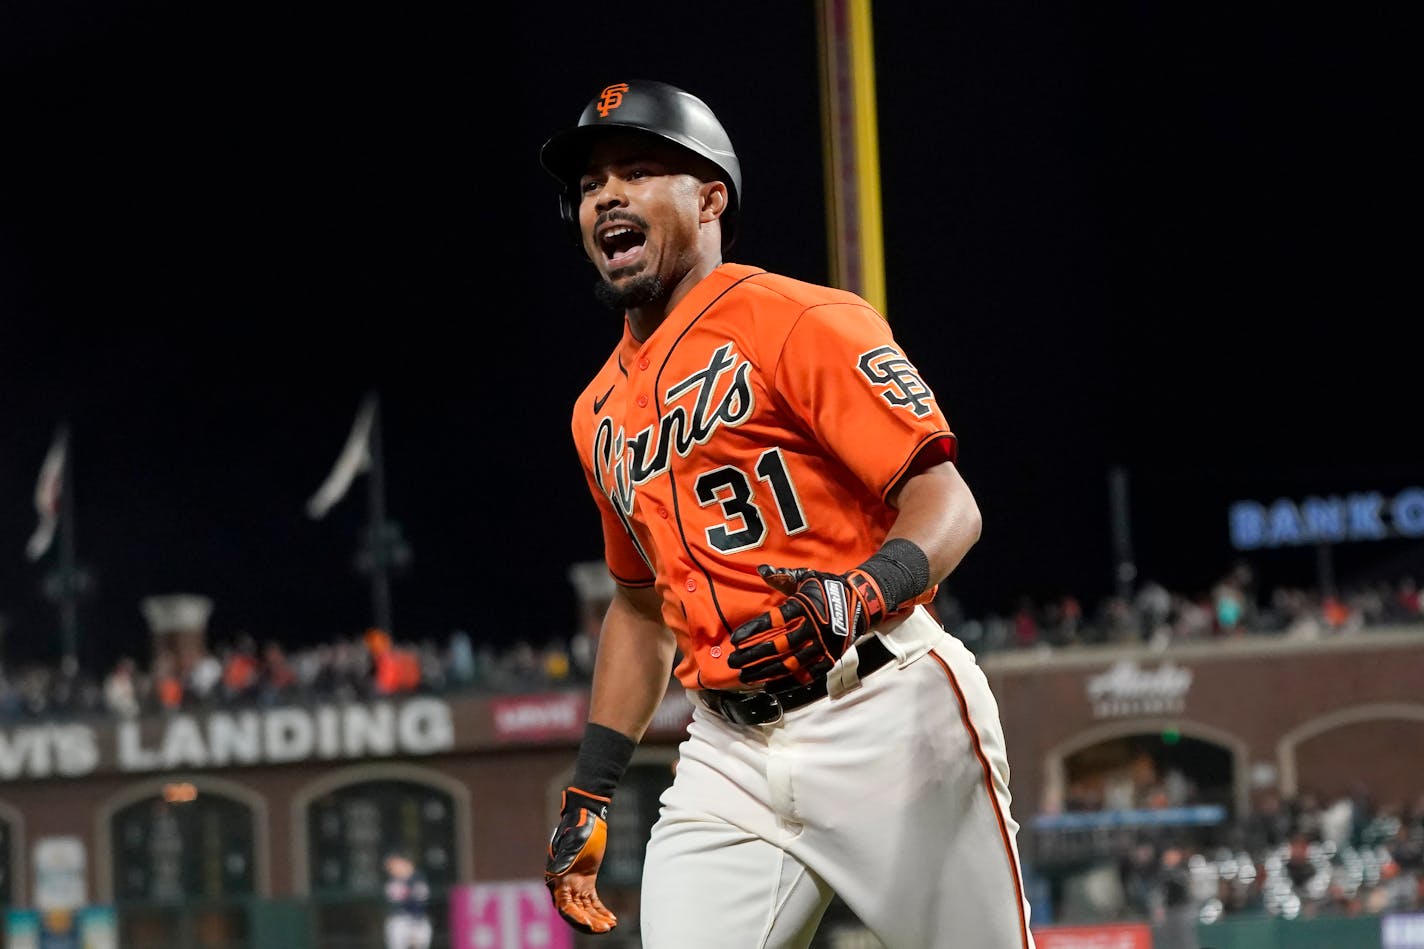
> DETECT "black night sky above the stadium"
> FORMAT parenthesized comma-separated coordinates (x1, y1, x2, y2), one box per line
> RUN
(0, 0, 1424, 667)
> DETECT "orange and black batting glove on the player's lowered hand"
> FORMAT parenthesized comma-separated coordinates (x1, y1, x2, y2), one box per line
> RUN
(544, 787, 618, 933)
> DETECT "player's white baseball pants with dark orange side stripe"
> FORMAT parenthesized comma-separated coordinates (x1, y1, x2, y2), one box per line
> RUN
(639, 607, 1034, 949)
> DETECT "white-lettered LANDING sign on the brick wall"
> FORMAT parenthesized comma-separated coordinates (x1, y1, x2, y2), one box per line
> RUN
(0, 697, 454, 782)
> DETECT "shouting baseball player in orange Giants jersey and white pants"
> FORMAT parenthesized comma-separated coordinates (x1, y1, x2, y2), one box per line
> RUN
(540, 80, 1034, 949)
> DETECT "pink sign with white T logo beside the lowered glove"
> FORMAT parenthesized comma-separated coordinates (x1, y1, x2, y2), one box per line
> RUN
(450, 881, 574, 949)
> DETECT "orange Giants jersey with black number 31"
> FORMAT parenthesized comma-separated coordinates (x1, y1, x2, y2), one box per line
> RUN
(572, 264, 956, 688)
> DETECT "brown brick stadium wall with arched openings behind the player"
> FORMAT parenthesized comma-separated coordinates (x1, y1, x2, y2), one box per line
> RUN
(0, 630, 1424, 902)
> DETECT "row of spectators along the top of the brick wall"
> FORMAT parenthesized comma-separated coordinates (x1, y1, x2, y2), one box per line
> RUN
(0, 563, 1424, 712)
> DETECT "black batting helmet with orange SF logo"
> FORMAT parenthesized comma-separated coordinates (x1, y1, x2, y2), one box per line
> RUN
(540, 80, 742, 251)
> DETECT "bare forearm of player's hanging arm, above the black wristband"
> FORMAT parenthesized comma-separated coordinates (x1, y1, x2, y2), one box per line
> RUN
(588, 591, 676, 741)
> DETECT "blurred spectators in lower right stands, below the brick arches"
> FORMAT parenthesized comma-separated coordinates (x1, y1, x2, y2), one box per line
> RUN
(1037, 752, 1424, 923)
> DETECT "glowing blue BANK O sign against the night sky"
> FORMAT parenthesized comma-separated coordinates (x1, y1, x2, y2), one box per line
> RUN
(1227, 487, 1424, 550)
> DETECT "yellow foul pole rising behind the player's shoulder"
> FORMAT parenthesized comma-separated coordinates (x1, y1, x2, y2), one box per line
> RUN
(817, 0, 886, 313)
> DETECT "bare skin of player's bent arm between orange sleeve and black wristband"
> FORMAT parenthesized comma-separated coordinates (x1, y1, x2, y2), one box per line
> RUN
(887, 462, 983, 584)
